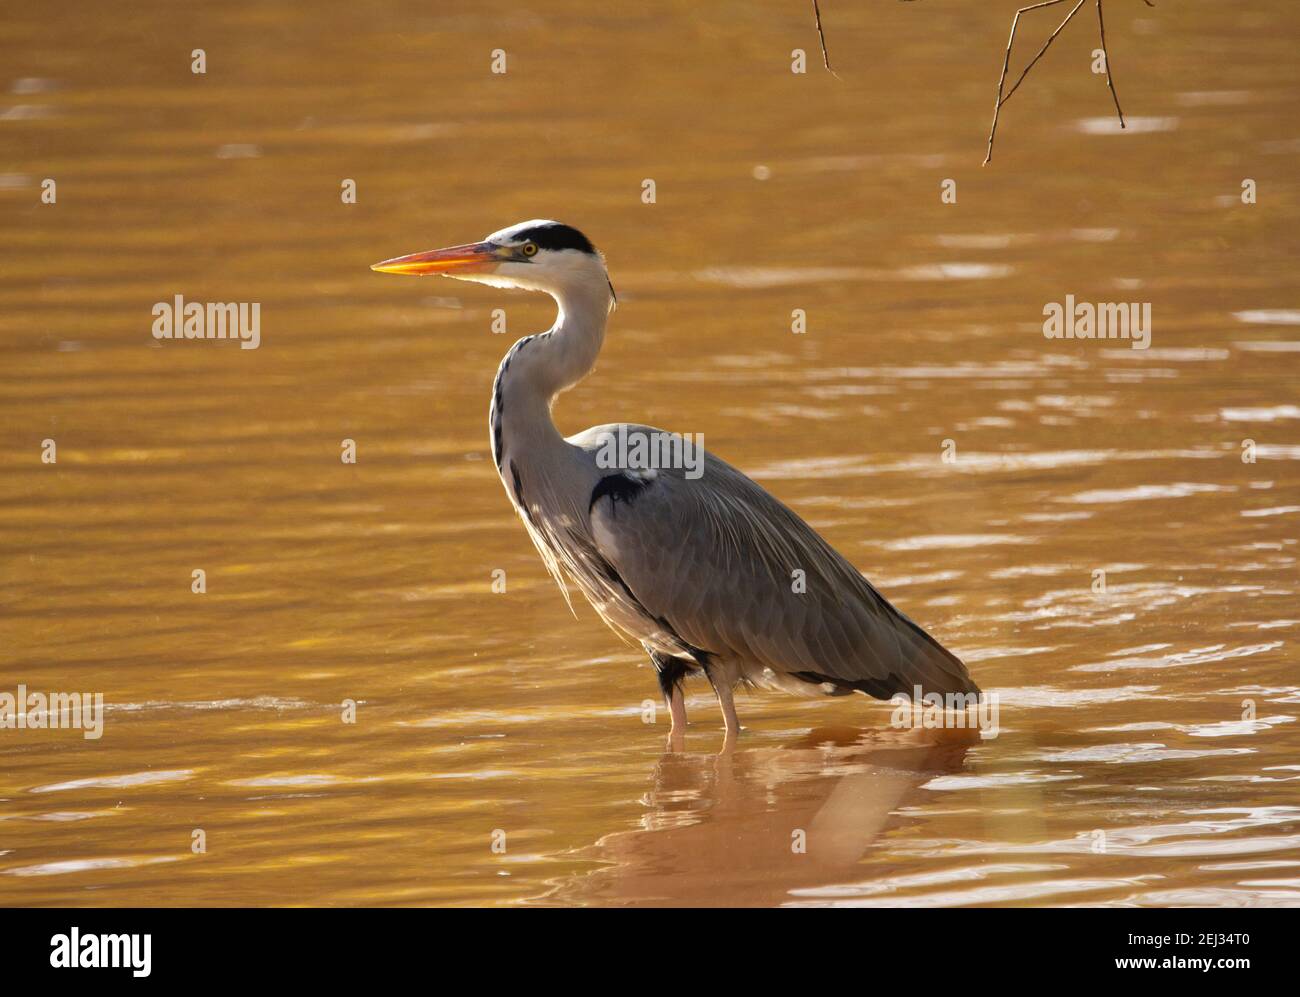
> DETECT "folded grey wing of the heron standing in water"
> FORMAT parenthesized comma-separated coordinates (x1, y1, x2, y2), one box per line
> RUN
(575, 441, 979, 699)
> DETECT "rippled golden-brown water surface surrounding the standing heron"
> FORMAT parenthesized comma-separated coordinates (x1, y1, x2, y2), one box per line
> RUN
(0, 0, 1300, 906)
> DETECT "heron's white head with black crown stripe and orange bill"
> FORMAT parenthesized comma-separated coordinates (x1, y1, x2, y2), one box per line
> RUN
(371, 218, 614, 306)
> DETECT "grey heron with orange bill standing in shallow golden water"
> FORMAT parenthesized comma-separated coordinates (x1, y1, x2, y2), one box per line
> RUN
(372, 220, 979, 741)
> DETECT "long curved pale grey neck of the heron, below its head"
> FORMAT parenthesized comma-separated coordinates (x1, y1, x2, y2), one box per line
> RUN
(489, 281, 610, 480)
